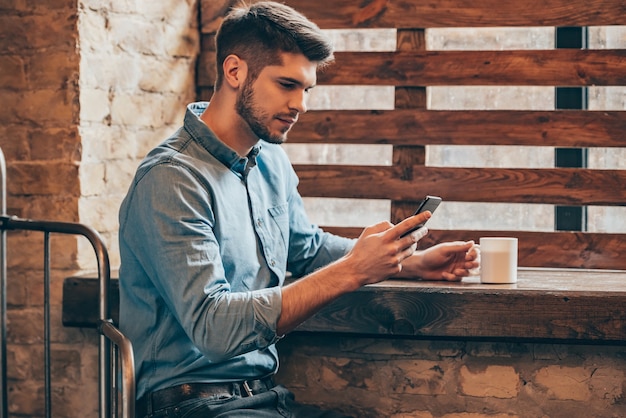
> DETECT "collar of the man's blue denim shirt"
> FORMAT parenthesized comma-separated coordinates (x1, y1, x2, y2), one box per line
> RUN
(185, 102, 261, 178)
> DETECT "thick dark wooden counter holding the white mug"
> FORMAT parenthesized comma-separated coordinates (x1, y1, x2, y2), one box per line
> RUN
(63, 268, 626, 345)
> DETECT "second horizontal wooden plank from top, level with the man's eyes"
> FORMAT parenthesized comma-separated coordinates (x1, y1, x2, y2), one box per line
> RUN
(318, 49, 626, 86)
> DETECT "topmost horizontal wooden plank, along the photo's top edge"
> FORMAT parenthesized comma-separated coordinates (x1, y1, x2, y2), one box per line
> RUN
(200, 0, 626, 33)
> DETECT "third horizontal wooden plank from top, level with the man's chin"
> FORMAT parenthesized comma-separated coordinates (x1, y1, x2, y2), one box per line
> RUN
(289, 109, 626, 147)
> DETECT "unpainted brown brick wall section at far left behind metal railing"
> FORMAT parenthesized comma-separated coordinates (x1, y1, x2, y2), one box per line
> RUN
(0, 1, 83, 416)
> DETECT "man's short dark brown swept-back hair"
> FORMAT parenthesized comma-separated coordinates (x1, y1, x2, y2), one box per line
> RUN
(215, 1, 333, 90)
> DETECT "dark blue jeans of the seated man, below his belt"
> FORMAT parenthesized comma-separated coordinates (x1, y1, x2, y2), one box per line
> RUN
(143, 385, 350, 418)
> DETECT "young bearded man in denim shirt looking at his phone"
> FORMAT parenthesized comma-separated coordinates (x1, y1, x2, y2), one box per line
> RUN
(120, 2, 477, 418)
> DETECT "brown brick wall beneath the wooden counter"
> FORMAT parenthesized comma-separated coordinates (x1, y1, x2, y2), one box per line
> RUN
(277, 334, 626, 418)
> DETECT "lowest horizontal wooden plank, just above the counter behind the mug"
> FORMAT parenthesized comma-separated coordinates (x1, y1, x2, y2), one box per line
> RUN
(323, 226, 626, 270)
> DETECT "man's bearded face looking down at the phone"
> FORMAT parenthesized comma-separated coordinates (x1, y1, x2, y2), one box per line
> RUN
(236, 53, 317, 144)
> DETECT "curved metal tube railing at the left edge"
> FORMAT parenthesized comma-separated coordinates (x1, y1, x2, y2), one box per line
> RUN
(0, 150, 135, 418)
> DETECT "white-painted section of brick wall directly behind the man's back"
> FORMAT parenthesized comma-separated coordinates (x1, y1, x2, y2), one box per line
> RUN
(78, 0, 199, 266)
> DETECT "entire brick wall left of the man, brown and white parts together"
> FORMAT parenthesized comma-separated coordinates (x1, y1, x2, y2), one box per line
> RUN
(0, 0, 199, 417)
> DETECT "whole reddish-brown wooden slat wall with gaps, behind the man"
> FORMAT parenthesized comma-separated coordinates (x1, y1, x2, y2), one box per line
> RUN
(198, 0, 626, 269)
